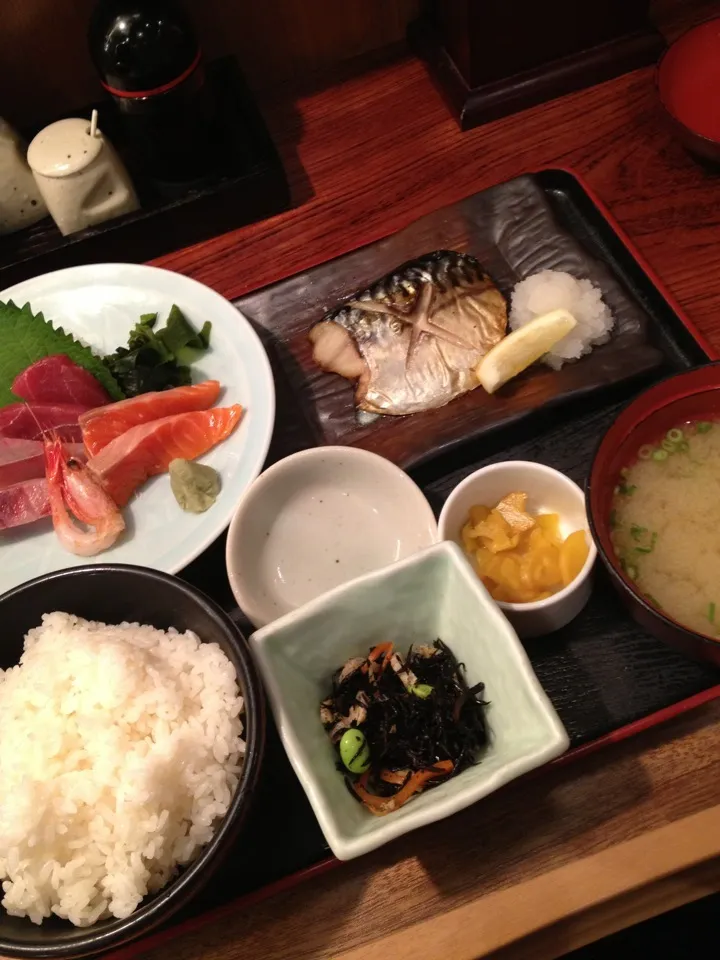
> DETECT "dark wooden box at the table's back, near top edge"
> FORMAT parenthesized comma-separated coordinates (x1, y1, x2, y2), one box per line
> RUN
(409, 0, 664, 129)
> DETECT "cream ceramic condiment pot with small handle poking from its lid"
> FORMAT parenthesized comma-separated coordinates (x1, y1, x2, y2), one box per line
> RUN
(28, 111, 140, 236)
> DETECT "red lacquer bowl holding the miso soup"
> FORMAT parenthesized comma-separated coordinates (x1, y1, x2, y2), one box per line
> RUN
(585, 363, 720, 666)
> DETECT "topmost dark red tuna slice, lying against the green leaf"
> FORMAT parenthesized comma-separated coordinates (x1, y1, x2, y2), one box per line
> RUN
(12, 353, 110, 410)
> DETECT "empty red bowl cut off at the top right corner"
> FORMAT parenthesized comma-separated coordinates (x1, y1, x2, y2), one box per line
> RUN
(655, 17, 720, 164)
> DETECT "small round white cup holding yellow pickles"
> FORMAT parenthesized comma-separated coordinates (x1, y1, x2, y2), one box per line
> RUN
(439, 460, 597, 639)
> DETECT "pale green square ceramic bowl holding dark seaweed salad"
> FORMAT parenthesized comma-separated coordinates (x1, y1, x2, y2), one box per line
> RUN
(250, 543, 569, 860)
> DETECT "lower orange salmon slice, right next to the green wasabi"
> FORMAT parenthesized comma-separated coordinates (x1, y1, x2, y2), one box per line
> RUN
(88, 403, 243, 507)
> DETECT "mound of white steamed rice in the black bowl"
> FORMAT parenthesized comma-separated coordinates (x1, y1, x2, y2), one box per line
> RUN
(0, 613, 245, 926)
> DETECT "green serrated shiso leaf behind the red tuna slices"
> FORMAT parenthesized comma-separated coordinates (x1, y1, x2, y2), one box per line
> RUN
(0, 300, 125, 407)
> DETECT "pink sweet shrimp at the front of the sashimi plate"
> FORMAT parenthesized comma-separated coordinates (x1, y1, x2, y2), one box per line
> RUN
(43, 436, 125, 557)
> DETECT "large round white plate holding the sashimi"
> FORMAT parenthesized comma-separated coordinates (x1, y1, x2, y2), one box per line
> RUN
(0, 263, 275, 593)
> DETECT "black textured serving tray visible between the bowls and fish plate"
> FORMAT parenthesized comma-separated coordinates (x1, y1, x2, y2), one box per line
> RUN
(160, 171, 720, 926)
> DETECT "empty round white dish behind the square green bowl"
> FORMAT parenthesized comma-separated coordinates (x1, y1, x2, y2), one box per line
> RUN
(225, 447, 438, 627)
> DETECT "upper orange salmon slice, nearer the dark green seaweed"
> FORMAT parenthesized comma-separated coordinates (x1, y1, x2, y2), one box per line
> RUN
(80, 380, 220, 457)
